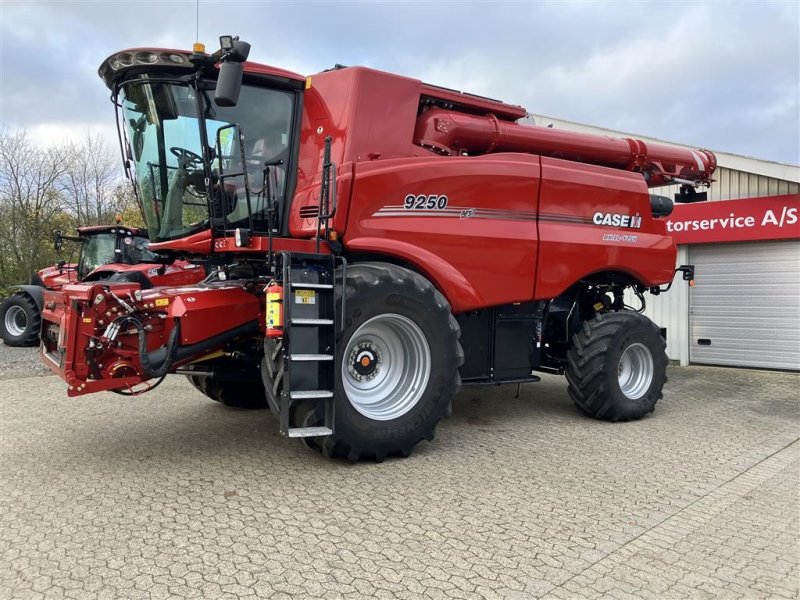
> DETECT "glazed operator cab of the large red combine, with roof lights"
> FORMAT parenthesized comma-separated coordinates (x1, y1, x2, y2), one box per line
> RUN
(100, 37, 301, 250)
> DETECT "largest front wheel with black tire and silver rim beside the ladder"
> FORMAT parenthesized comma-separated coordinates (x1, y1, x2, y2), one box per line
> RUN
(268, 263, 464, 462)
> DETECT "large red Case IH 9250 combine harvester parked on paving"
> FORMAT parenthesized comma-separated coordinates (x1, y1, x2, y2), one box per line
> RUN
(42, 37, 715, 460)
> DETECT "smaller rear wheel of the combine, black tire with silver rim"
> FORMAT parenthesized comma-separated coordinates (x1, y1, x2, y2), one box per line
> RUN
(567, 311, 667, 421)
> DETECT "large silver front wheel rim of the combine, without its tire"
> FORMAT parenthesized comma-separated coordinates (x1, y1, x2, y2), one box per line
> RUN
(342, 314, 431, 421)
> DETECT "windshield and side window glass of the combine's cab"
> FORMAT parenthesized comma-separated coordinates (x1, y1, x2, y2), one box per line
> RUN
(120, 78, 293, 241)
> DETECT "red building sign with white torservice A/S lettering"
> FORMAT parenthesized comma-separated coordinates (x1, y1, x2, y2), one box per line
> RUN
(666, 194, 800, 244)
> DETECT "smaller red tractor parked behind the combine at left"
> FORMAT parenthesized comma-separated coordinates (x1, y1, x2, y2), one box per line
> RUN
(0, 225, 205, 346)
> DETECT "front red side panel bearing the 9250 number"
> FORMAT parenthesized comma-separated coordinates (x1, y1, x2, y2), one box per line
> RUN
(344, 155, 540, 312)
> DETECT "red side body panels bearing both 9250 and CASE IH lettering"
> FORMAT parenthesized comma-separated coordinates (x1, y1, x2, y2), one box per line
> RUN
(343, 154, 677, 313)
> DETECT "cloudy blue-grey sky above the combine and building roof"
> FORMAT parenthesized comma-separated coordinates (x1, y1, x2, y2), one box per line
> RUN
(0, 0, 800, 164)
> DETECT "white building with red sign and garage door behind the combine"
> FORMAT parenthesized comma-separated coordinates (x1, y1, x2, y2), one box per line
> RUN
(531, 115, 800, 370)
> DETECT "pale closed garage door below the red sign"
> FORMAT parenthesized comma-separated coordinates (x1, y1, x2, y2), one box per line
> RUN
(689, 240, 800, 370)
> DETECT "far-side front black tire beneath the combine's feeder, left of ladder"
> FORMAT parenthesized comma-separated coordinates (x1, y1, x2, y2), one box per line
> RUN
(186, 359, 268, 409)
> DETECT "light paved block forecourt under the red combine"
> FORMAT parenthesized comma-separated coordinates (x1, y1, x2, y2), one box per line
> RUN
(0, 360, 800, 599)
